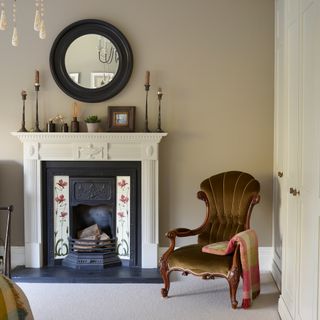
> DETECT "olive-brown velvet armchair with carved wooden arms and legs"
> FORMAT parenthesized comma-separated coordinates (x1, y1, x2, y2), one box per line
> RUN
(160, 171, 260, 308)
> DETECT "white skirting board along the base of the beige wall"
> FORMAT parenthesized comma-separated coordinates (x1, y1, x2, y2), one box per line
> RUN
(0, 246, 273, 271)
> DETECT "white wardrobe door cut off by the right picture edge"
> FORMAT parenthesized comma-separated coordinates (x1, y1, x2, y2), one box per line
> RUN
(297, 0, 320, 320)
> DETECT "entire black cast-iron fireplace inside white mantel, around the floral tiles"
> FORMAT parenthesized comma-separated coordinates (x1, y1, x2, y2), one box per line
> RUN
(42, 161, 141, 270)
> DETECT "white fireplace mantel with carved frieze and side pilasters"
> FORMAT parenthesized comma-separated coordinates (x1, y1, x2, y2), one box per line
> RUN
(12, 132, 167, 268)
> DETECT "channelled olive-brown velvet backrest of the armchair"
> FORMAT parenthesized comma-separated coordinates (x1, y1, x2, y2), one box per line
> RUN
(198, 171, 260, 244)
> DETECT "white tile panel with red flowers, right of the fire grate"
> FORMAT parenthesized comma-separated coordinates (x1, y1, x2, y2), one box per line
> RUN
(116, 176, 130, 259)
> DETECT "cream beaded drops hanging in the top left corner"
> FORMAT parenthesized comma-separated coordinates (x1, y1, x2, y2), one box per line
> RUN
(0, 0, 46, 47)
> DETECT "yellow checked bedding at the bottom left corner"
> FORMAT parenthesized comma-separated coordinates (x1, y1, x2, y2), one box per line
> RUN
(0, 274, 33, 320)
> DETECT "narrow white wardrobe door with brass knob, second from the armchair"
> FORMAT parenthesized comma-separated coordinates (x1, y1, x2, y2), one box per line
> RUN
(281, 0, 300, 319)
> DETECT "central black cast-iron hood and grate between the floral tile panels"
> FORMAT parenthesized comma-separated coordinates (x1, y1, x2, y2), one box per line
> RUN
(62, 177, 121, 270)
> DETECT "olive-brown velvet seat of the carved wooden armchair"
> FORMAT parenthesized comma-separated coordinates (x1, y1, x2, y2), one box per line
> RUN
(168, 244, 232, 276)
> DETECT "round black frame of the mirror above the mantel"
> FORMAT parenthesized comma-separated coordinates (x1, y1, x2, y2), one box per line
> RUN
(50, 19, 133, 102)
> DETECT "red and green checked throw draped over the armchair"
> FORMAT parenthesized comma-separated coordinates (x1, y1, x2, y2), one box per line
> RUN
(202, 229, 260, 309)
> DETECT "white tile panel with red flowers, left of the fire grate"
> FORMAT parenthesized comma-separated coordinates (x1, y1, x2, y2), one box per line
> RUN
(53, 176, 70, 259)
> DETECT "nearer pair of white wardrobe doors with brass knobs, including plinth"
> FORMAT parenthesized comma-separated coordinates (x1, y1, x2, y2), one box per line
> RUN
(279, 0, 320, 320)
